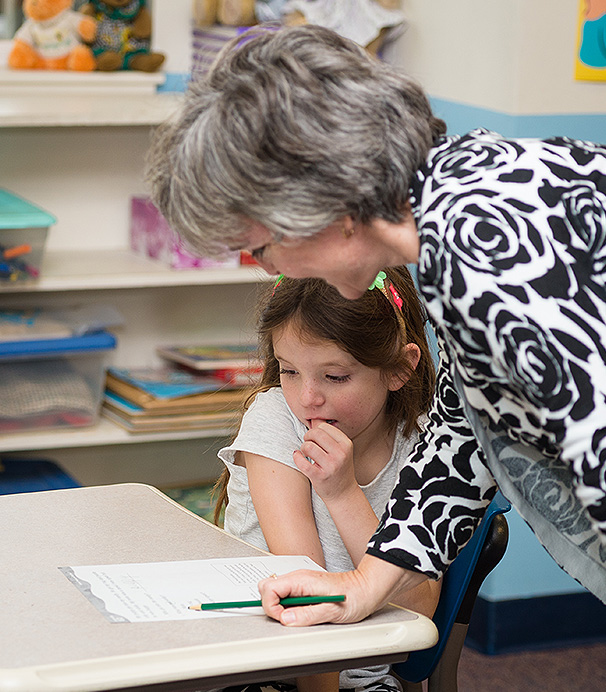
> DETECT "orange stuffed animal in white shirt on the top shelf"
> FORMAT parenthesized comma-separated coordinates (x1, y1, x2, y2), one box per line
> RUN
(8, 0, 97, 72)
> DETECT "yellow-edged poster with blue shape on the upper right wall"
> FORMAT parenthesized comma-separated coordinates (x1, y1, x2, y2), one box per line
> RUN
(574, 0, 606, 81)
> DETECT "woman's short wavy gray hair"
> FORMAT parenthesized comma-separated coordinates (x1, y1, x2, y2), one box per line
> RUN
(147, 26, 445, 256)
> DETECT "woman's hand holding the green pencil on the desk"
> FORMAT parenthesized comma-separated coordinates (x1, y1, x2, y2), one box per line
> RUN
(259, 555, 426, 627)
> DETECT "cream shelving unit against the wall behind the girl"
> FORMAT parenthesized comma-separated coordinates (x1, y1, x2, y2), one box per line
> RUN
(0, 58, 254, 484)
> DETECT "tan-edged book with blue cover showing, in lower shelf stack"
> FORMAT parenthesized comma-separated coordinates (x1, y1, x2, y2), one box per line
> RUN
(106, 367, 251, 409)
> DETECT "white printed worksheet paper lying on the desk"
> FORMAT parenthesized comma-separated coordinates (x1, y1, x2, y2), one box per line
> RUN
(59, 555, 324, 622)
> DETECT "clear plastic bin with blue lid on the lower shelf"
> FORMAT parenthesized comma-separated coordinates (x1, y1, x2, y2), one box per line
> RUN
(0, 332, 116, 433)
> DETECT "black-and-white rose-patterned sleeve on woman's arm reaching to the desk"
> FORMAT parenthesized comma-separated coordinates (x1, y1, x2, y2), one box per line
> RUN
(367, 350, 496, 579)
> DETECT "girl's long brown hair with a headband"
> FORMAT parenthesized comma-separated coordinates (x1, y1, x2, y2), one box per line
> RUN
(215, 267, 435, 522)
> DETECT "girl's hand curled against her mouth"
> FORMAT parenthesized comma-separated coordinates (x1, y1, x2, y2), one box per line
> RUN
(293, 422, 359, 504)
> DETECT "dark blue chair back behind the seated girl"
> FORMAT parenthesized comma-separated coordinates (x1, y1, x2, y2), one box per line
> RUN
(392, 492, 511, 683)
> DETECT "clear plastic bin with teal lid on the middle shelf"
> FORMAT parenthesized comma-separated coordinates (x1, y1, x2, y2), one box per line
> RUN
(0, 189, 57, 288)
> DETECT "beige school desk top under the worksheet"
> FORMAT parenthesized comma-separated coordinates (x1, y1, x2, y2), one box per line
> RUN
(0, 484, 437, 692)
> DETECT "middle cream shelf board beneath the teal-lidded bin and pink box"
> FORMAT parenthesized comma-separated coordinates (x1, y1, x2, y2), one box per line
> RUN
(0, 249, 270, 295)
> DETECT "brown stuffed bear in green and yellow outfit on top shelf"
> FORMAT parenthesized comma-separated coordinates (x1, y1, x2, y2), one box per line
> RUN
(81, 0, 164, 72)
